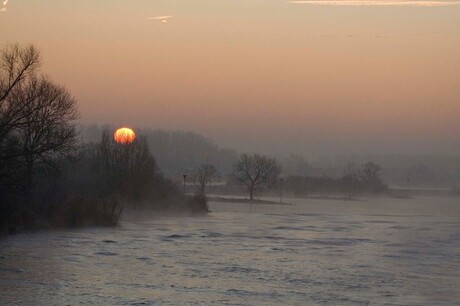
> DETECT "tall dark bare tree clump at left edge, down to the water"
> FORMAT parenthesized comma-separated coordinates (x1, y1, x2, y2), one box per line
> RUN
(0, 44, 78, 228)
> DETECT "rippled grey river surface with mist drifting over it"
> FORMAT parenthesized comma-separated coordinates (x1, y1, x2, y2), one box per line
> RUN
(0, 198, 460, 305)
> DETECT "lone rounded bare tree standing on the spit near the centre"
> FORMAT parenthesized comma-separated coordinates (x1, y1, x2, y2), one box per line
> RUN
(233, 154, 281, 200)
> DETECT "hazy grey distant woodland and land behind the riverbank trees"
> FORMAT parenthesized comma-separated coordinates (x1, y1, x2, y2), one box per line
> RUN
(80, 125, 460, 195)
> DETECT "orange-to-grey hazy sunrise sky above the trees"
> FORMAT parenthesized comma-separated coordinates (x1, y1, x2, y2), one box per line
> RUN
(0, 0, 460, 155)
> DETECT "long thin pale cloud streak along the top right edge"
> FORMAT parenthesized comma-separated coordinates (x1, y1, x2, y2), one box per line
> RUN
(288, 0, 460, 7)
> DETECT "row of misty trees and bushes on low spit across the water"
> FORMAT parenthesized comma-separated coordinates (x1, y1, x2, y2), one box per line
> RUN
(210, 157, 388, 200)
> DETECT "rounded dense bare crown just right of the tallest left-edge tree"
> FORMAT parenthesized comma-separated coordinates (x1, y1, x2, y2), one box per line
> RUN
(9, 77, 78, 175)
